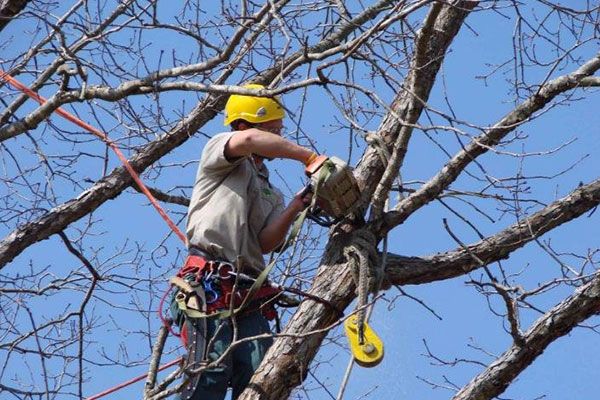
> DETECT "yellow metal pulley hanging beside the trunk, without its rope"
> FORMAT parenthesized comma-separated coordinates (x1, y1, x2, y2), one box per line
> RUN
(344, 315, 383, 368)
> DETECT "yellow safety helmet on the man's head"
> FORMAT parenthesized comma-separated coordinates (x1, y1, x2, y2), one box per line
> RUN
(223, 84, 285, 125)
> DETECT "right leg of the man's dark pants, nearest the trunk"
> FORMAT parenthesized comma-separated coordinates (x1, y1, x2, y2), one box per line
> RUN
(231, 311, 273, 400)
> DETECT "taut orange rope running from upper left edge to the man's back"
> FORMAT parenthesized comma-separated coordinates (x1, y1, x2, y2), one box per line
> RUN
(0, 71, 187, 245)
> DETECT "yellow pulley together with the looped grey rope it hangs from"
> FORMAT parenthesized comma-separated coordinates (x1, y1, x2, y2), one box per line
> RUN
(344, 230, 384, 367)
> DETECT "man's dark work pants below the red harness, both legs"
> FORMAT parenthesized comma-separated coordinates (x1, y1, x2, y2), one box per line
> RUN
(180, 311, 273, 400)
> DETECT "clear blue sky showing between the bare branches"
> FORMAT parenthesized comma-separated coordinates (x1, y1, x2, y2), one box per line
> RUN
(0, 2, 600, 400)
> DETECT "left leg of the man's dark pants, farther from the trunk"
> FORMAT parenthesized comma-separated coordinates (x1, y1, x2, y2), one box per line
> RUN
(185, 318, 233, 400)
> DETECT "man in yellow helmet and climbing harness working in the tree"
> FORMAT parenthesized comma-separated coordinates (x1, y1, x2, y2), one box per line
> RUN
(172, 84, 322, 400)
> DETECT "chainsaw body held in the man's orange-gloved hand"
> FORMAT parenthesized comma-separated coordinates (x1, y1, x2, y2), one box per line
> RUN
(305, 156, 360, 218)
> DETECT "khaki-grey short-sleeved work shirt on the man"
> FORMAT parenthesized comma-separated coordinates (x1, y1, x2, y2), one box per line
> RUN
(187, 132, 284, 270)
